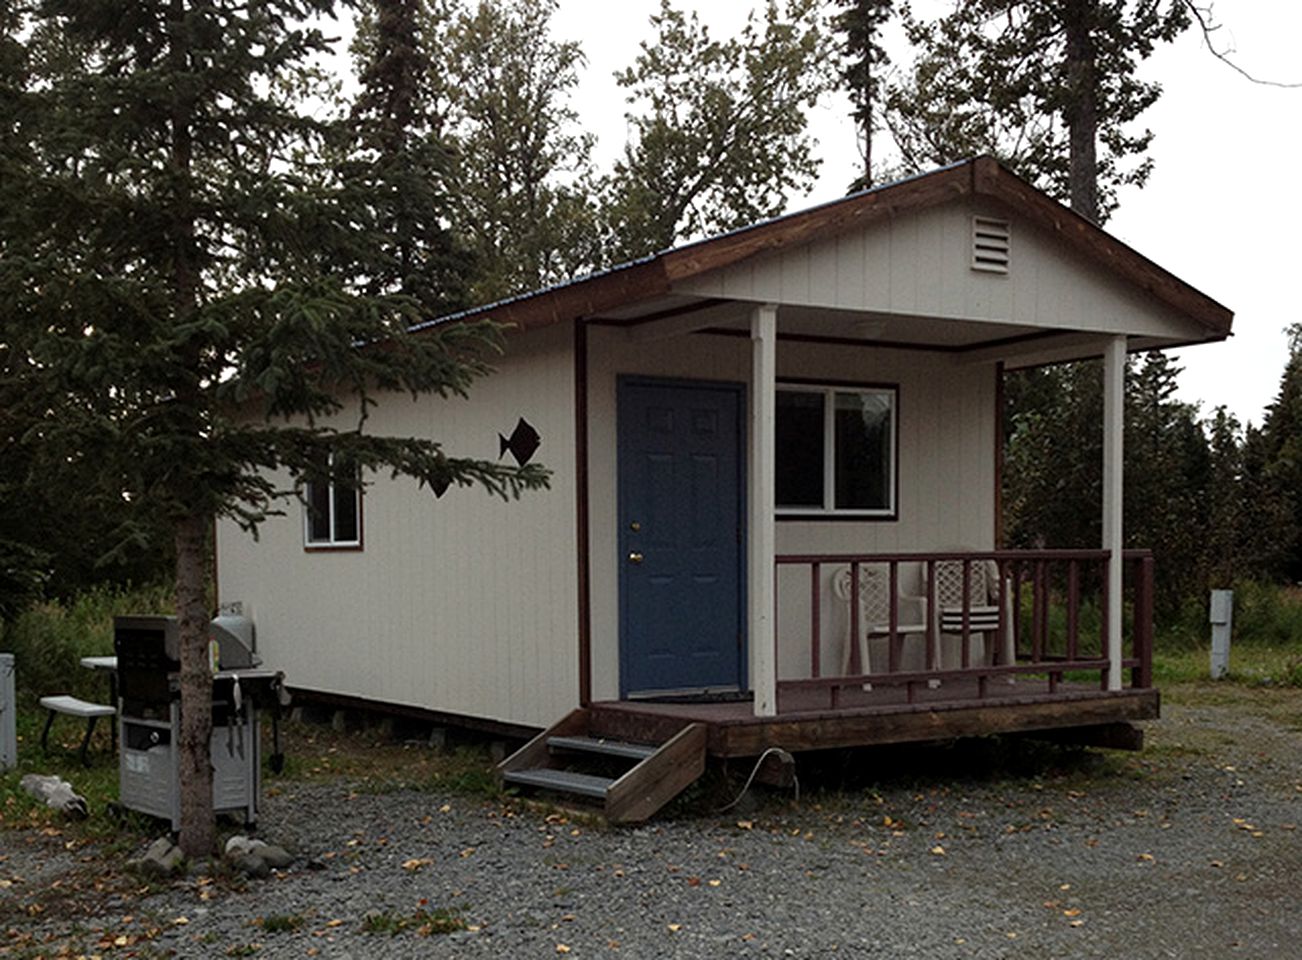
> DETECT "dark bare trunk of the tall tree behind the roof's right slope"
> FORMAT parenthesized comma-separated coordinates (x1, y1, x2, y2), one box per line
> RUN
(1062, 0, 1099, 223)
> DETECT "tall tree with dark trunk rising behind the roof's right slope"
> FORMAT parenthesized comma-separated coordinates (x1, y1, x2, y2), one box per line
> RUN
(887, 0, 1190, 223)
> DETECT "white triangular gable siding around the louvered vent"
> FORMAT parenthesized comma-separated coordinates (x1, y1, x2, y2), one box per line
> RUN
(676, 199, 1204, 339)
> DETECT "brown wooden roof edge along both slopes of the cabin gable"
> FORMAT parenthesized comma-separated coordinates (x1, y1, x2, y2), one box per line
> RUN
(415, 156, 1233, 356)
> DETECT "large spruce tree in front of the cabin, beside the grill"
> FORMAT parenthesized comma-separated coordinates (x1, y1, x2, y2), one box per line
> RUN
(0, 0, 546, 856)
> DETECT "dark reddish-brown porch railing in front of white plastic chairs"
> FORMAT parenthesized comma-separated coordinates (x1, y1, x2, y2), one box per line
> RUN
(775, 550, 1154, 709)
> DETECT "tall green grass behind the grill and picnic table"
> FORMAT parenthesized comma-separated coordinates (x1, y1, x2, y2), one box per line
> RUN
(0, 575, 174, 703)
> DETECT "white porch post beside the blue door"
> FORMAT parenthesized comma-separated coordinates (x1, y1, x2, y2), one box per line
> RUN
(746, 304, 777, 716)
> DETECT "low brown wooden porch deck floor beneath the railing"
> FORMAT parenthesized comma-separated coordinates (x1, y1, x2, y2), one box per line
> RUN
(590, 677, 1160, 757)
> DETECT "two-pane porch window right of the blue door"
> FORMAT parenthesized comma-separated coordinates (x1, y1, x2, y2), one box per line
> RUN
(775, 386, 897, 517)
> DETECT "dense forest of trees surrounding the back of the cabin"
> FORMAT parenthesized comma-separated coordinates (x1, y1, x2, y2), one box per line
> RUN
(0, 0, 1302, 687)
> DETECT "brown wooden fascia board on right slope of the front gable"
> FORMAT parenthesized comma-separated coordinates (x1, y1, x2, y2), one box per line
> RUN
(971, 156, 1234, 337)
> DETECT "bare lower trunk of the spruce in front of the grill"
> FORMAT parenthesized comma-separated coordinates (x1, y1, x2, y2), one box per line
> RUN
(176, 513, 216, 858)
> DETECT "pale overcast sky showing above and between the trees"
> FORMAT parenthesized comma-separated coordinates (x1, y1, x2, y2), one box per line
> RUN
(553, 0, 1302, 423)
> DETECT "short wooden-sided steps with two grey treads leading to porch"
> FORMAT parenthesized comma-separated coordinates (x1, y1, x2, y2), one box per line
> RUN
(497, 709, 706, 823)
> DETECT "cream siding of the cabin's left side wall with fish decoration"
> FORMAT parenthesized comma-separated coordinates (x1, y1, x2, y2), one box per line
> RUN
(217, 324, 578, 726)
